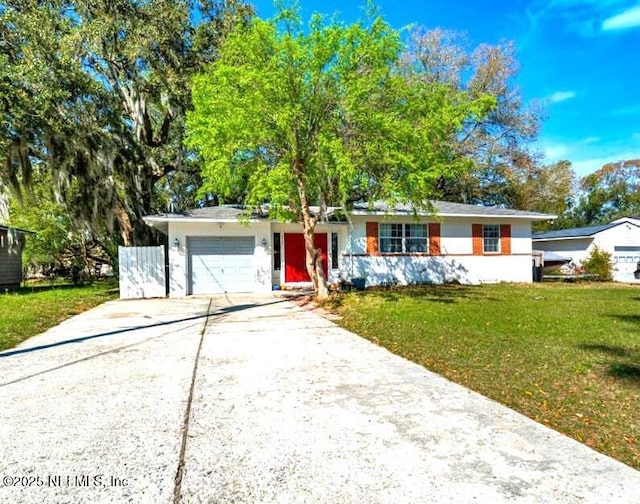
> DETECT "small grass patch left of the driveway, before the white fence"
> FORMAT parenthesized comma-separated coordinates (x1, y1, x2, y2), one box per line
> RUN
(0, 282, 118, 350)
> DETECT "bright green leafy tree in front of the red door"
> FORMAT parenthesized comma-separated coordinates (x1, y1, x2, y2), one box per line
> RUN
(188, 9, 496, 297)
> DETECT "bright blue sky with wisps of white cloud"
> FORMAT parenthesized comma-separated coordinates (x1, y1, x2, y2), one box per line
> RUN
(252, 0, 640, 176)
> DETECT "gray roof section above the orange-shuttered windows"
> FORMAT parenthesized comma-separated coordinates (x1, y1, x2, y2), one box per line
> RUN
(353, 201, 557, 220)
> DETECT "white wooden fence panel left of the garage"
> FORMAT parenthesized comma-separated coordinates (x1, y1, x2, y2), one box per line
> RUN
(118, 246, 167, 299)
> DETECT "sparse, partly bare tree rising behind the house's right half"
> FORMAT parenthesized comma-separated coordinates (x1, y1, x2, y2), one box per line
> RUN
(404, 28, 544, 210)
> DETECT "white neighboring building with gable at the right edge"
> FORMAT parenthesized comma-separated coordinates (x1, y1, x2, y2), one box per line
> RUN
(533, 217, 640, 282)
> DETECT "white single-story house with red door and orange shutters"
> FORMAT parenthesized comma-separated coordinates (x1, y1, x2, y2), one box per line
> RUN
(145, 202, 555, 297)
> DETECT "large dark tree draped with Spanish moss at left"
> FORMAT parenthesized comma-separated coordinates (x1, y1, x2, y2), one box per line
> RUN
(0, 0, 252, 244)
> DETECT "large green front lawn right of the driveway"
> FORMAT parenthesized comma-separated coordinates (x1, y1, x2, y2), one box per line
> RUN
(330, 284, 640, 469)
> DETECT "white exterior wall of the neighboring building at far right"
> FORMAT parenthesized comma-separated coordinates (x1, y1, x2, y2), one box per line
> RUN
(534, 219, 640, 282)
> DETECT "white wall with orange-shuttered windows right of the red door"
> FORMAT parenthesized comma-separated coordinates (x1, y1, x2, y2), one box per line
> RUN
(341, 215, 533, 285)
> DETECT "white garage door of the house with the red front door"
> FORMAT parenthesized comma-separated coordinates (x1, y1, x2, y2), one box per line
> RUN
(187, 236, 256, 294)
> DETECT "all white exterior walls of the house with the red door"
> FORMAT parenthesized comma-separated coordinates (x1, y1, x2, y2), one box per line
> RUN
(168, 216, 532, 297)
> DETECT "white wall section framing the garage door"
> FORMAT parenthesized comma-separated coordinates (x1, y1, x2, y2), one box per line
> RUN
(168, 221, 271, 297)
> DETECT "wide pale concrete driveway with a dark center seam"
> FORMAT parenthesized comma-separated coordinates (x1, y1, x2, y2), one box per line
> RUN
(0, 296, 640, 504)
